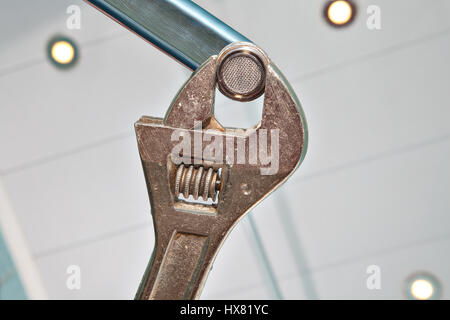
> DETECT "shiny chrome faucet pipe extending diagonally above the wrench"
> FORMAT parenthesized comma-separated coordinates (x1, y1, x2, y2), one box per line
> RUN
(85, 0, 250, 70)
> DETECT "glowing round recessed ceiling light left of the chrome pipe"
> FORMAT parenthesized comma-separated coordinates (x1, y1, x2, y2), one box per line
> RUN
(47, 37, 78, 68)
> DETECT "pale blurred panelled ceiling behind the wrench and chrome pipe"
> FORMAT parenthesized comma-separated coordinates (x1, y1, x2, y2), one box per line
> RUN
(0, 0, 450, 299)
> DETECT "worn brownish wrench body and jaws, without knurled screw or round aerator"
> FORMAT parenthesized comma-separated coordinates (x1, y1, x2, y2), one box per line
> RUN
(135, 43, 307, 299)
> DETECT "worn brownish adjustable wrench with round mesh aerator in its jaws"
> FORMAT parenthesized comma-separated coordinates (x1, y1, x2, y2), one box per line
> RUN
(135, 43, 307, 299)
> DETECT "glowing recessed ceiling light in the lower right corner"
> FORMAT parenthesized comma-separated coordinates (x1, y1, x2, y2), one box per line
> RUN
(406, 273, 440, 300)
